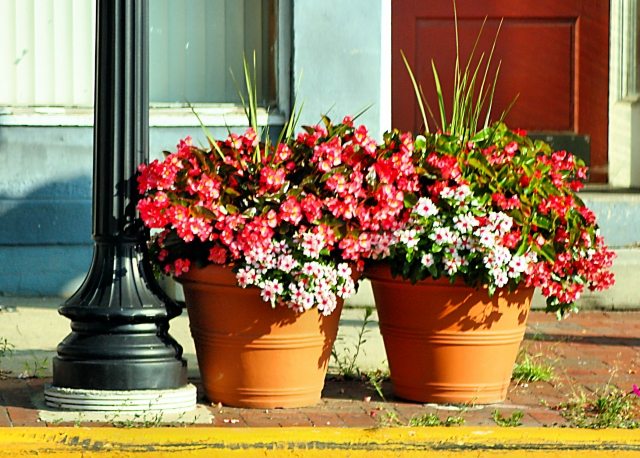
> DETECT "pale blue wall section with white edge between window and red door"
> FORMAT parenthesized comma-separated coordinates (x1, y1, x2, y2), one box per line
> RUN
(292, 0, 391, 138)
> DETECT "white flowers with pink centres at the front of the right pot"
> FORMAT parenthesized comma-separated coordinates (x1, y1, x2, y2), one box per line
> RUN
(372, 184, 537, 292)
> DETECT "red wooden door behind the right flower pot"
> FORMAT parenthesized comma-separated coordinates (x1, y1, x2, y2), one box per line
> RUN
(392, 0, 609, 182)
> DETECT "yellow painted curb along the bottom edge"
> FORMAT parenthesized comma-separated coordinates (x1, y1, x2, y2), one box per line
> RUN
(0, 427, 640, 458)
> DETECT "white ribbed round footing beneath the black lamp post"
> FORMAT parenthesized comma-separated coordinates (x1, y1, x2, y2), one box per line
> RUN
(44, 384, 196, 413)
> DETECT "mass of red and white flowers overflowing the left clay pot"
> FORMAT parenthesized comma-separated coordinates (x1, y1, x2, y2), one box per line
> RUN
(138, 117, 384, 314)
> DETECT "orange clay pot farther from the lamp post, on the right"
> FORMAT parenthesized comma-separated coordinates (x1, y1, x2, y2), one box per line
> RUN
(366, 265, 533, 404)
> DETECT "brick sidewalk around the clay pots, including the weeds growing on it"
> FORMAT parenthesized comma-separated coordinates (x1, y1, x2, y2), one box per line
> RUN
(0, 311, 640, 428)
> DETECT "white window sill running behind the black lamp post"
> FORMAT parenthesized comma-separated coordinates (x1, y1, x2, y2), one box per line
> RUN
(0, 104, 285, 127)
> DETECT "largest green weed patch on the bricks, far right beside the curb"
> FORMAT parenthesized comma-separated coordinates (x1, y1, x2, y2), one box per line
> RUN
(559, 386, 640, 429)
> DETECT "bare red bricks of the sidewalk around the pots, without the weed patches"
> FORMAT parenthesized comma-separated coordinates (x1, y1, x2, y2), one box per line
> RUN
(0, 311, 640, 428)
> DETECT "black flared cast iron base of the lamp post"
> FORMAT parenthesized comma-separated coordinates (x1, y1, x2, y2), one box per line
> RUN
(53, 243, 187, 390)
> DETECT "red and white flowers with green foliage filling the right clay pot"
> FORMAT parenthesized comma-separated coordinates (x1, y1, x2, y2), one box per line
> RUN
(371, 123, 614, 315)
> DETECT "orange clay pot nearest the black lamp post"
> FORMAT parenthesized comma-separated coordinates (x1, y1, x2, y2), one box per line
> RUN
(179, 265, 342, 409)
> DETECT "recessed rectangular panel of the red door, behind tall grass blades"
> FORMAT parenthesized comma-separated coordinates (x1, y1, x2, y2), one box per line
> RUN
(413, 19, 573, 130)
